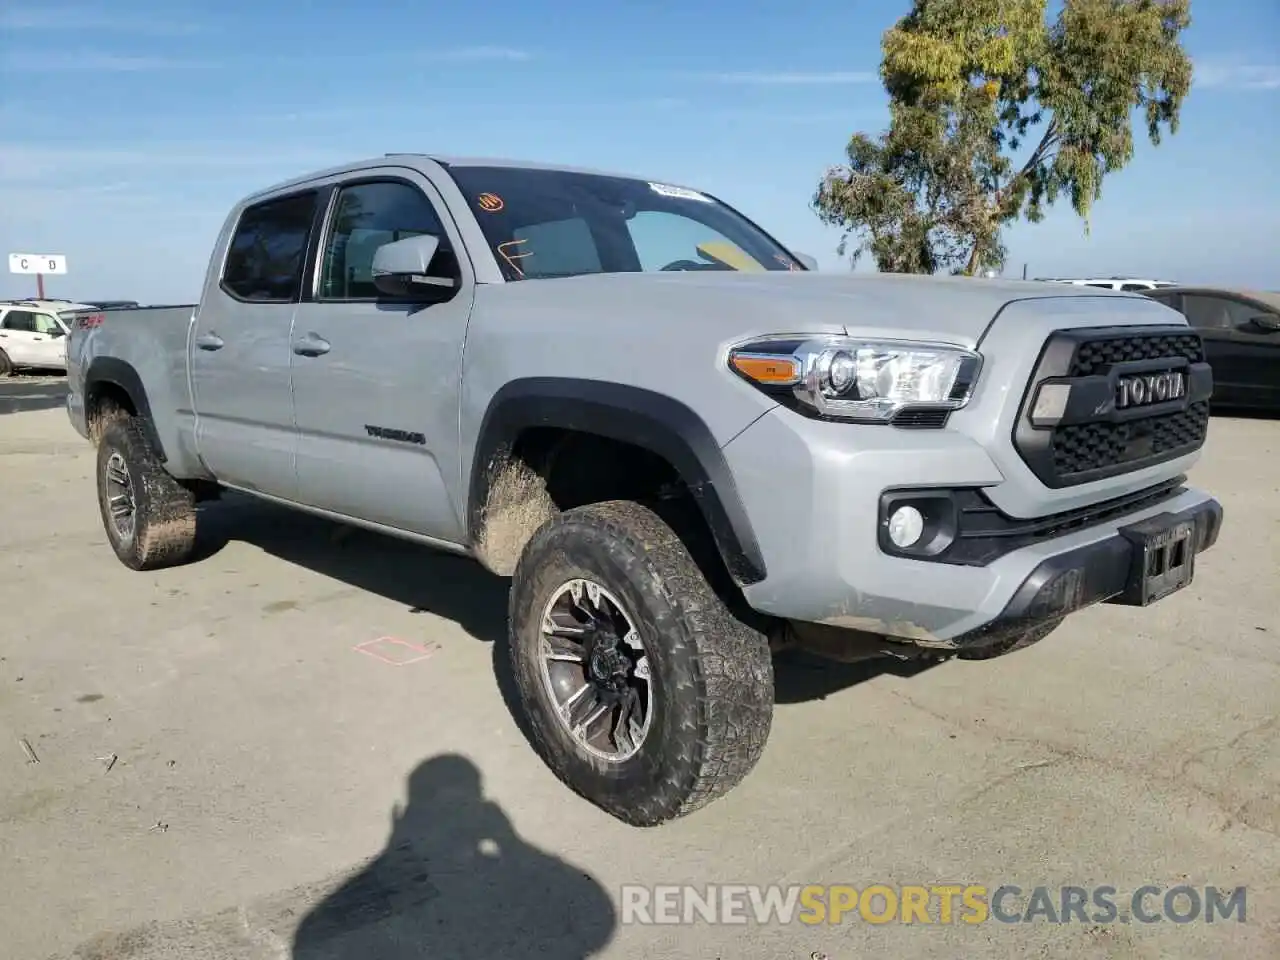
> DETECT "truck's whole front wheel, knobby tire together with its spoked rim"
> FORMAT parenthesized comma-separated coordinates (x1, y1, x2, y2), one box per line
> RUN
(509, 500, 773, 827)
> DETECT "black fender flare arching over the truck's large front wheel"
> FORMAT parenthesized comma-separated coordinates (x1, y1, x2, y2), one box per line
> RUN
(467, 376, 765, 586)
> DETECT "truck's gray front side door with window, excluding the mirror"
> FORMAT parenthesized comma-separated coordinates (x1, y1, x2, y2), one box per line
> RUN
(292, 170, 475, 543)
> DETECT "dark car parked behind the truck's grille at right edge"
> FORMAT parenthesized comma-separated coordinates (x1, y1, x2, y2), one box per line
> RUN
(1144, 287, 1280, 412)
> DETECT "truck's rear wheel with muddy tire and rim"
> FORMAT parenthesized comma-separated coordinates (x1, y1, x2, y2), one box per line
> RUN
(97, 417, 196, 570)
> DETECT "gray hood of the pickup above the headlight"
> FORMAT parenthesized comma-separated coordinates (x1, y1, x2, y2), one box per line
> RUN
(483, 270, 1151, 349)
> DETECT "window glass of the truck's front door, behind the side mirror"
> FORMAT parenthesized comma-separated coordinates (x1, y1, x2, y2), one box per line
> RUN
(320, 180, 457, 300)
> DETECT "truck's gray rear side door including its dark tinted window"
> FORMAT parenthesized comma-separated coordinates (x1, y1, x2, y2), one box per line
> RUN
(191, 189, 321, 499)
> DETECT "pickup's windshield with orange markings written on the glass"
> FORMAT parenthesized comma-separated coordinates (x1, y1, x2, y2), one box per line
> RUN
(449, 166, 805, 280)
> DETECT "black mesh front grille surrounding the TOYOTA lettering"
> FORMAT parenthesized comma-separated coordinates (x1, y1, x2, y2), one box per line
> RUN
(1014, 326, 1212, 488)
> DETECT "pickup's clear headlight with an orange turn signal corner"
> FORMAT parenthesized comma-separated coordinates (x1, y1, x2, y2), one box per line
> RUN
(728, 337, 982, 426)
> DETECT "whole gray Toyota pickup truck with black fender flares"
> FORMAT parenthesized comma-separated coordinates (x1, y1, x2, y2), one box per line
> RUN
(68, 155, 1222, 826)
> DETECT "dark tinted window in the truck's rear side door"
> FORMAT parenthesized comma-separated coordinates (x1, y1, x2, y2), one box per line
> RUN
(223, 191, 316, 303)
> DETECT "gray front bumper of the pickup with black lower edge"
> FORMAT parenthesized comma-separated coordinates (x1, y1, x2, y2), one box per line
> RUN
(724, 411, 1222, 649)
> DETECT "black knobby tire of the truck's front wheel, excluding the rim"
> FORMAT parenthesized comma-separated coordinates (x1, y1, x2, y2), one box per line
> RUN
(508, 500, 773, 827)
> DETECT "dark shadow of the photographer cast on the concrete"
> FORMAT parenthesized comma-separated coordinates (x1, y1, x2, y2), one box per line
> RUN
(292, 754, 617, 960)
